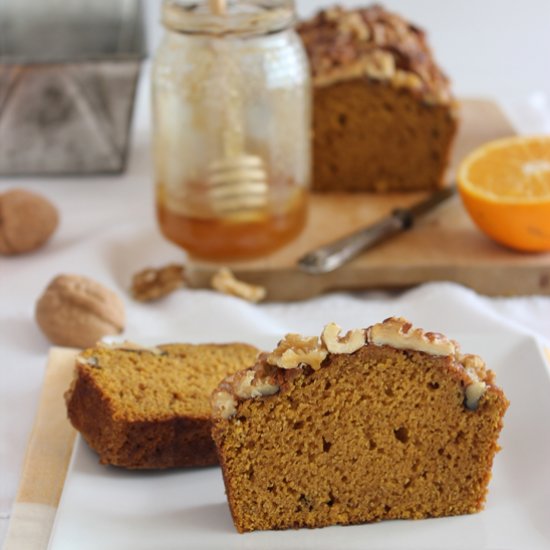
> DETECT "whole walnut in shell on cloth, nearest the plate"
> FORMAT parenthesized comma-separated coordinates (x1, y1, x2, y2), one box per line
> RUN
(35, 275, 125, 348)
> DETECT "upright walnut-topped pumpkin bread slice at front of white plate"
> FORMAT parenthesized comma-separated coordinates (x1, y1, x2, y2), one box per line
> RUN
(212, 318, 508, 532)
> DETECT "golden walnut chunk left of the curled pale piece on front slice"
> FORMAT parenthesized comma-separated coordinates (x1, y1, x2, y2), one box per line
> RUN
(267, 334, 328, 370)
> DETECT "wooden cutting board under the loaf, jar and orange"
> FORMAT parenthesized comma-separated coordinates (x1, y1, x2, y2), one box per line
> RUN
(187, 100, 550, 301)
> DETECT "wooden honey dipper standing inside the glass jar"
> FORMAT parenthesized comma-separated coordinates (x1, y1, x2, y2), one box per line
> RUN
(208, 0, 269, 217)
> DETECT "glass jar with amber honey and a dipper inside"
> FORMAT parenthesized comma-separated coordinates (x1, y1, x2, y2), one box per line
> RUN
(153, 0, 311, 260)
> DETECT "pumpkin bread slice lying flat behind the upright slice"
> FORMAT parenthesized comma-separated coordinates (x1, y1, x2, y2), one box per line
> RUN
(65, 343, 258, 469)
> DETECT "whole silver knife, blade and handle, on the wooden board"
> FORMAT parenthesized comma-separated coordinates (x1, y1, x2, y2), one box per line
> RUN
(298, 185, 456, 275)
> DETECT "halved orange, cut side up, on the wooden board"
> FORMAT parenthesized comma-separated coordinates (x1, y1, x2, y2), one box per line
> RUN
(457, 136, 550, 252)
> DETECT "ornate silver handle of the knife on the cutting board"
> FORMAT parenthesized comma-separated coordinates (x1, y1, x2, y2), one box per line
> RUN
(298, 216, 406, 274)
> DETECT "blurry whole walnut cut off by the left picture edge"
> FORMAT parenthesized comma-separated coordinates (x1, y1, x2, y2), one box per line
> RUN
(0, 189, 59, 255)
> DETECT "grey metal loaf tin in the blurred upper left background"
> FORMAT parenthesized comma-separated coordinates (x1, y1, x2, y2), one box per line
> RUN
(0, 0, 146, 175)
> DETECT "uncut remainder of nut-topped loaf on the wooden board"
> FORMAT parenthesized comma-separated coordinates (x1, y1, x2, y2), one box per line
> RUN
(298, 5, 458, 192)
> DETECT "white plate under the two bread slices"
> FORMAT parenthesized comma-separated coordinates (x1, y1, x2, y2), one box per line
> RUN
(50, 332, 550, 550)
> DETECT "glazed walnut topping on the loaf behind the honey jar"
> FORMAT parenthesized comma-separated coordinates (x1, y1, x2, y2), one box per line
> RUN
(298, 5, 452, 103)
